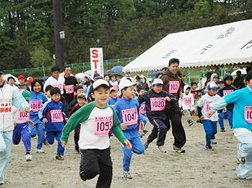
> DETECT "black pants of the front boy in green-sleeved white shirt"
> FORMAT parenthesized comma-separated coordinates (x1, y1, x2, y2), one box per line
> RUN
(80, 148, 112, 188)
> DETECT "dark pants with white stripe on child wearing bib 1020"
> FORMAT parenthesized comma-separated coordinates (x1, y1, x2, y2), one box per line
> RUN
(147, 118, 168, 146)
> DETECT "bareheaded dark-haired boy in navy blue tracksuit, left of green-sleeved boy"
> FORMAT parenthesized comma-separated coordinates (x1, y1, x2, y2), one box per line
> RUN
(41, 88, 68, 160)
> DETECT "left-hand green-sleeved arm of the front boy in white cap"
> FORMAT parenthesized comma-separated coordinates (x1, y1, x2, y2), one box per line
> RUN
(60, 103, 94, 145)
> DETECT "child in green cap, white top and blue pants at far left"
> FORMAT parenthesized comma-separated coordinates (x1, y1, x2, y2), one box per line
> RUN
(12, 90, 33, 161)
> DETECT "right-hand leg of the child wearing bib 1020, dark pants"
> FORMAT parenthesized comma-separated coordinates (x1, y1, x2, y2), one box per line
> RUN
(151, 119, 167, 146)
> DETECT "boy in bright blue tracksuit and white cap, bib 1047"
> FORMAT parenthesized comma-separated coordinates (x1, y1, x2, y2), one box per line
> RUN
(114, 79, 145, 179)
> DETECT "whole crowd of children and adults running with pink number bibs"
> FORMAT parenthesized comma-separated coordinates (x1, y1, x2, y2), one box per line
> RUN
(0, 63, 252, 187)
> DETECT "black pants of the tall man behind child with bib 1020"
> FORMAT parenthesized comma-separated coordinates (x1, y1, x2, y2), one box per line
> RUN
(167, 109, 186, 148)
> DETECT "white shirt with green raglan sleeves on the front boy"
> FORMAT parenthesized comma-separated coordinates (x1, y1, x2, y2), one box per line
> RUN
(61, 102, 126, 150)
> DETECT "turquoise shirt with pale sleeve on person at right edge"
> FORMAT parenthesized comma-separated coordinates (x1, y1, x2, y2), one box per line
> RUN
(210, 86, 252, 135)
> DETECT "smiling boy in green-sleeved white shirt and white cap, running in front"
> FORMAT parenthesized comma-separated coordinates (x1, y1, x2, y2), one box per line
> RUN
(61, 79, 131, 188)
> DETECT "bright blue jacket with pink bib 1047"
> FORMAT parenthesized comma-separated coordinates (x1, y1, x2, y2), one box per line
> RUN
(114, 97, 146, 131)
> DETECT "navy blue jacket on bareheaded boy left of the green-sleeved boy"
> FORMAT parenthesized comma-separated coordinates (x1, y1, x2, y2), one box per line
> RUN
(40, 100, 66, 132)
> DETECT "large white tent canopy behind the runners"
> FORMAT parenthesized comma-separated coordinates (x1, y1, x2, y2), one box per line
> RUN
(123, 20, 252, 72)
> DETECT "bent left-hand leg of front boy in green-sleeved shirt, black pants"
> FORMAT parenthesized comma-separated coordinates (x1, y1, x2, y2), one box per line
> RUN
(80, 149, 100, 181)
